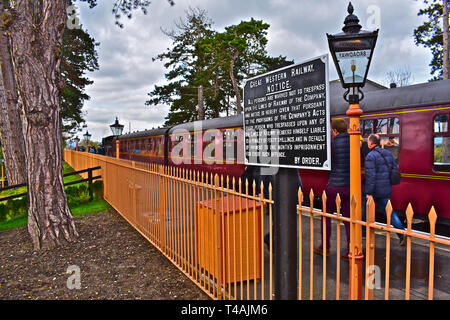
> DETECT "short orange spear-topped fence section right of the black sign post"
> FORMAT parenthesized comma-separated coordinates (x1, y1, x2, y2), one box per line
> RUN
(298, 191, 450, 300)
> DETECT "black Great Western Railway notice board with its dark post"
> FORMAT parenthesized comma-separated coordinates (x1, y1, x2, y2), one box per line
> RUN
(244, 55, 331, 299)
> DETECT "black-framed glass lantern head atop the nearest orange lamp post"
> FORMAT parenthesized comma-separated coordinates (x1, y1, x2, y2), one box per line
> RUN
(327, 2, 378, 104)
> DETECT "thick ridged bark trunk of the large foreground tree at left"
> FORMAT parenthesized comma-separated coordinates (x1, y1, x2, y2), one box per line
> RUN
(8, 0, 78, 250)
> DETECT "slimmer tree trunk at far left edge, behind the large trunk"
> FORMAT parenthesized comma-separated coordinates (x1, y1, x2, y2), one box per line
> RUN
(0, 24, 26, 185)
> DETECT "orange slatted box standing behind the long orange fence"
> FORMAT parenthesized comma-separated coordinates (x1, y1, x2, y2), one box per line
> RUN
(195, 196, 263, 283)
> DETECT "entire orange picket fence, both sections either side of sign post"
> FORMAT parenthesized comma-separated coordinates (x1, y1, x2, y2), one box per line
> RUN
(64, 150, 450, 299)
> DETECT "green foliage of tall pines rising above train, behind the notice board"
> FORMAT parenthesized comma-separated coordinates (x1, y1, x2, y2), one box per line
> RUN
(146, 8, 292, 125)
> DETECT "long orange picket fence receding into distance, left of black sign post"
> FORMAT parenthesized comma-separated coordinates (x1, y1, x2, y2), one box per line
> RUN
(65, 150, 273, 299)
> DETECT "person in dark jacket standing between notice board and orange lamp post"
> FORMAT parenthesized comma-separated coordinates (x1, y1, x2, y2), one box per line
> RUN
(314, 119, 350, 259)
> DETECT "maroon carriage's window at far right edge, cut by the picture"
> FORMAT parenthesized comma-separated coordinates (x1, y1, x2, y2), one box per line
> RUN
(433, 114, 450, 172)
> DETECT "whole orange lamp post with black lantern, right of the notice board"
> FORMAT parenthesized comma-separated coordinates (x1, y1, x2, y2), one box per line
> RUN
(327, 2, 378, 300)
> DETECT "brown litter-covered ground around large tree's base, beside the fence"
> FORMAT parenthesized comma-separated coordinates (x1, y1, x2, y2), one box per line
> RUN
(0, 209, 209, 300)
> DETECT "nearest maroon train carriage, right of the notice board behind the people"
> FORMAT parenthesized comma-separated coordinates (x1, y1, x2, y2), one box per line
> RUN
(300, 80, 450, 223)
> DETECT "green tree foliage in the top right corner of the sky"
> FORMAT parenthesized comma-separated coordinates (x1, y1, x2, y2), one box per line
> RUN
(414, 0, 449, 80)
